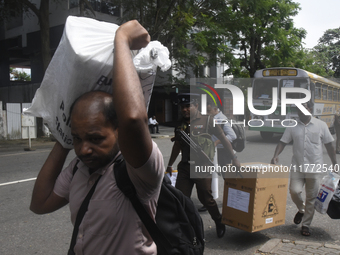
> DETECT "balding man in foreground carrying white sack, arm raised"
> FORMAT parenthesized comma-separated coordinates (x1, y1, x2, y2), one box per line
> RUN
(30, 21, 165, 255)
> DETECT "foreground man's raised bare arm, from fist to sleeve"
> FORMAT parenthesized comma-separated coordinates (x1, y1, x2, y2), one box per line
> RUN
(112, 20, 152, 168)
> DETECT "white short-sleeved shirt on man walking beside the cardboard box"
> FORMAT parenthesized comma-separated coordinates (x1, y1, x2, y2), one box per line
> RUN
(281, 117, 334, 173)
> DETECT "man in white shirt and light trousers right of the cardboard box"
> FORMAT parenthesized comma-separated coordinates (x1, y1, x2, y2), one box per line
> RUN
(271, 103, 337, 236)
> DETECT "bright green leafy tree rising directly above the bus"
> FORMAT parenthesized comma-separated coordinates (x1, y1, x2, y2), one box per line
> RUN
(223, 0, 306, 77)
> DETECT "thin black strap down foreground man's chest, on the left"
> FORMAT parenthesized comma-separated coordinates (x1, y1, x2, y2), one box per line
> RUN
(67, 160, 102, 255)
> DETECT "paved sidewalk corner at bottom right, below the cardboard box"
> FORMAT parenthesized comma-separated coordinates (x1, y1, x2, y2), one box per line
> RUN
(254, 239, 340, 255)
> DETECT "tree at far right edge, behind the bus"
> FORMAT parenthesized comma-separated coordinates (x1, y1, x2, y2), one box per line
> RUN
(313, 27, 340, 78)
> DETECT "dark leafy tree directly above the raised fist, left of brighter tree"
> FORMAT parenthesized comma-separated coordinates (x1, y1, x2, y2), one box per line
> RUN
(111, 0, 231, 83)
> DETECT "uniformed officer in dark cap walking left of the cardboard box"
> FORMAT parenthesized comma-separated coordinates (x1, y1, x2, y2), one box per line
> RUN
(166, 93, 240, 237)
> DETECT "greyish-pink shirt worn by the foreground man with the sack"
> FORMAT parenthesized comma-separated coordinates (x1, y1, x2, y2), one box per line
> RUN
(54, 142, 165, 255)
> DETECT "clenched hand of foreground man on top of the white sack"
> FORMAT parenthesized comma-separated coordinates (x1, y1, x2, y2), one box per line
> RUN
(115, 20, 150, 50)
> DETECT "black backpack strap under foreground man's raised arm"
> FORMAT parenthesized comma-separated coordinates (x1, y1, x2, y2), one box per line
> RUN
(114, 155, 172, 255)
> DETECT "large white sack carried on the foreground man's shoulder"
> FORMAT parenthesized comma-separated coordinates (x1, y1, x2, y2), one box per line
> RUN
(24, 16, 171, 149)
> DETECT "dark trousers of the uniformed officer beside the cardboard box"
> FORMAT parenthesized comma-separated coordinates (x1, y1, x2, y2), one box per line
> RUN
(176, 162, 221, 220)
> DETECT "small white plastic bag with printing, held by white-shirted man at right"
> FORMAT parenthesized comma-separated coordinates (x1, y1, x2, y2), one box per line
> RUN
(314, 173, 340, 214)
